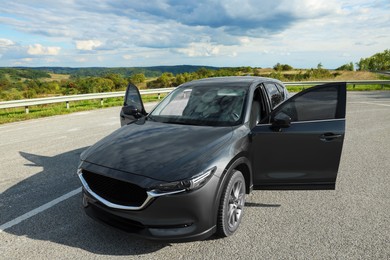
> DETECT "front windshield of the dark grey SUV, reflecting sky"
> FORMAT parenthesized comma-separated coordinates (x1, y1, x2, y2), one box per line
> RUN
(149, 84, 247, 126)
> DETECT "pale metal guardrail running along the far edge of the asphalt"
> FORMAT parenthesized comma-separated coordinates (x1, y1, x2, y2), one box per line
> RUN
(0, 80, 390, 113)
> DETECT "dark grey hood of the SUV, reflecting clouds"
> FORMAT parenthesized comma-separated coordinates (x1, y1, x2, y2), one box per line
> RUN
(81, 120, 232, 181)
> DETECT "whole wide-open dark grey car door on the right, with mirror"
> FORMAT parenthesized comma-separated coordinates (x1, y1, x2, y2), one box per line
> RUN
(251, 83, 346, 189)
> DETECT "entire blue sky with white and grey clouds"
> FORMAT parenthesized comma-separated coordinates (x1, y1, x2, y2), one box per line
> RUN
(0, 0, 390, 69)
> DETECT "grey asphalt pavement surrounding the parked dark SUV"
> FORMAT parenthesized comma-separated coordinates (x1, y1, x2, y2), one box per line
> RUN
(0, 92, 390, 259)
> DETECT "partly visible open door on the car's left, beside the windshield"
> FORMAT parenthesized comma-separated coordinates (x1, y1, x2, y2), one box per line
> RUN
(120, 83, 146, 126)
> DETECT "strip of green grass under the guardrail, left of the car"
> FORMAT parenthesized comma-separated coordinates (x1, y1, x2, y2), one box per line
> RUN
(0, 95, 164, 124)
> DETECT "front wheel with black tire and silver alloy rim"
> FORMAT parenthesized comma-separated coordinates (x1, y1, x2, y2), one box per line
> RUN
(217, 170, 245, 237)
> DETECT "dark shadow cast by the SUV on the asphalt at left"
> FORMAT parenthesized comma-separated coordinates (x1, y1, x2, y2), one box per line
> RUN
(0, 148, 170, 255)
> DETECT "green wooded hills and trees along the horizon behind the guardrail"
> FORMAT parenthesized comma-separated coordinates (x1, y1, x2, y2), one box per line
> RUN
(0, 50, 390, 100)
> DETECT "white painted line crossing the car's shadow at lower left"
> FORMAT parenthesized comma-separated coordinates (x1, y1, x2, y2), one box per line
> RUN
(0, 187, 81, 233)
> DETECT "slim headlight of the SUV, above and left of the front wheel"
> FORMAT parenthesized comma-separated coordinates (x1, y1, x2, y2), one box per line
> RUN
(152, 167, 217, 193)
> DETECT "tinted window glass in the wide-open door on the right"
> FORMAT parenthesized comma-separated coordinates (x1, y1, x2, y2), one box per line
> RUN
(277, 86, 338, 122)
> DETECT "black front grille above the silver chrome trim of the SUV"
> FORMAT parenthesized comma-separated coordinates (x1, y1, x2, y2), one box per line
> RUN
(83, 170, 148, 207)
